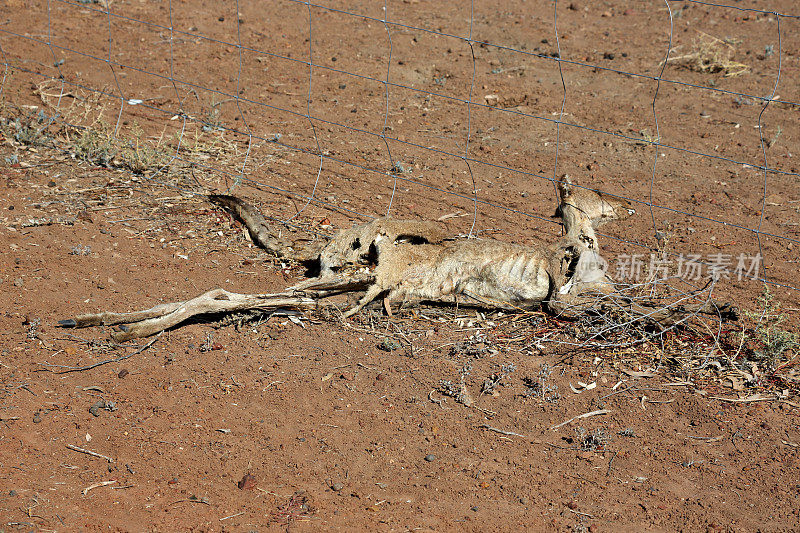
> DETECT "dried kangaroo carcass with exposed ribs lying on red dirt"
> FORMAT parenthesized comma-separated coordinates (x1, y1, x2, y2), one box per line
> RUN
(61, 176, 735, 340)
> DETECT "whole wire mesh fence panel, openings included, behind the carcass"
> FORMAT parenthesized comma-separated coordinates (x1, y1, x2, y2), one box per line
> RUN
(0, 0, 800, 308)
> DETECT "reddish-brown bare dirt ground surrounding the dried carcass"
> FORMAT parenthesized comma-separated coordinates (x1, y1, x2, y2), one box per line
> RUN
(0, 0, 800, 531)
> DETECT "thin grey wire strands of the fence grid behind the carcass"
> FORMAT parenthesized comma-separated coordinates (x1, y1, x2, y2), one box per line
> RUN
(0, 0, 800, 300)
